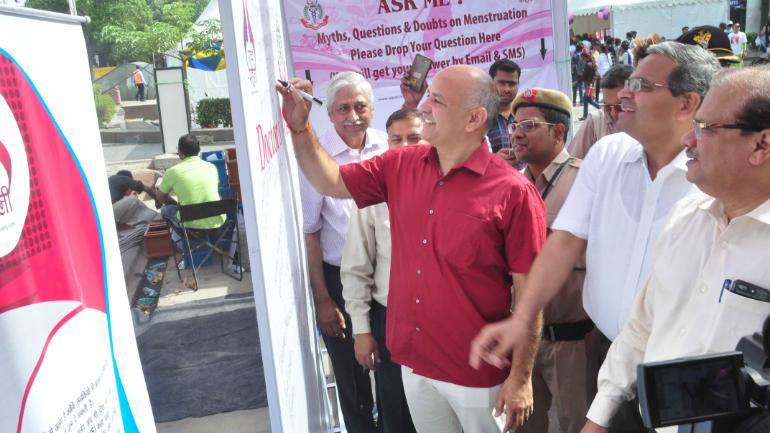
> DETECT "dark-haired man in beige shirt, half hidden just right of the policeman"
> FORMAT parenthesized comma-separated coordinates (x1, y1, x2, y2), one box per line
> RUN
(570, 65, 634, 159)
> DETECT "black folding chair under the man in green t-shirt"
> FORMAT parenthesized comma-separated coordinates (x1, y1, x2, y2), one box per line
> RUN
(168, 199, 243, 290)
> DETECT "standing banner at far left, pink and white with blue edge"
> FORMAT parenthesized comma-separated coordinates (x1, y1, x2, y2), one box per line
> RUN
(0, 6, 155, 433)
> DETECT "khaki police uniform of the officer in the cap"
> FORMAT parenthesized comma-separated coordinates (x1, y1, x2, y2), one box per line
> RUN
(516, 149, 588, 433)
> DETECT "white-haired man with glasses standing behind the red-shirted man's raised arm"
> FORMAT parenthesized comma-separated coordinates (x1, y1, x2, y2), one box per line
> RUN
(300, 72, 388, 433)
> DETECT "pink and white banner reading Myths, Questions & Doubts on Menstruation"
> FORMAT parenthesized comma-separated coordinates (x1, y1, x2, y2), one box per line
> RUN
(284, 0, 562, 130)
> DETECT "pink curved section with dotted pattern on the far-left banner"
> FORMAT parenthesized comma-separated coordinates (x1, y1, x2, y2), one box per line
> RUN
(0, 52, 106, 313)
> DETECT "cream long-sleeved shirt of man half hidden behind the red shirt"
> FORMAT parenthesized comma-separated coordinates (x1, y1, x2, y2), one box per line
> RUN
(340, 203, 391, 335)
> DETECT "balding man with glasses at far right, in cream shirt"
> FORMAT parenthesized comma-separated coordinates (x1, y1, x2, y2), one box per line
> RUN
(584, 66, 770, 433)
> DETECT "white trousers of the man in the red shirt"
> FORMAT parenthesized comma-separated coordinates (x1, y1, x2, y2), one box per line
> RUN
(401, 366, 505, 433)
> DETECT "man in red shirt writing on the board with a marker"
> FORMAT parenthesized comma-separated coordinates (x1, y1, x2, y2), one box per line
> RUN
(276, 65, 545, 433)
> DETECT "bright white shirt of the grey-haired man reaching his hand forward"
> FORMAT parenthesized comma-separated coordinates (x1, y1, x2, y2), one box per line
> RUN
(552, 133, 697, 340)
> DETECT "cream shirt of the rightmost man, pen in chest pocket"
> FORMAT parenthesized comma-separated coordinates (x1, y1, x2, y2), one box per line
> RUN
(588, 193, 770, 432)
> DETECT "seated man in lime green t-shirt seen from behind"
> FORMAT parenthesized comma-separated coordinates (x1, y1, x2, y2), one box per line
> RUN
(157, 134, 225, 229)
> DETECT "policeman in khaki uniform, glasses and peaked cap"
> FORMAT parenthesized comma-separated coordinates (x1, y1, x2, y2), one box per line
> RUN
(512, 88, 594, 433)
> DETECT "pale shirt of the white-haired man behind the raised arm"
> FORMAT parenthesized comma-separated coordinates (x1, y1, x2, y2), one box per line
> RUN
(300, 127, 388, 266)
